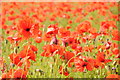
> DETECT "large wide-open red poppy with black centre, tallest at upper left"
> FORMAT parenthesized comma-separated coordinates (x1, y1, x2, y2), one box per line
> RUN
(18, 17, 39, 39)
